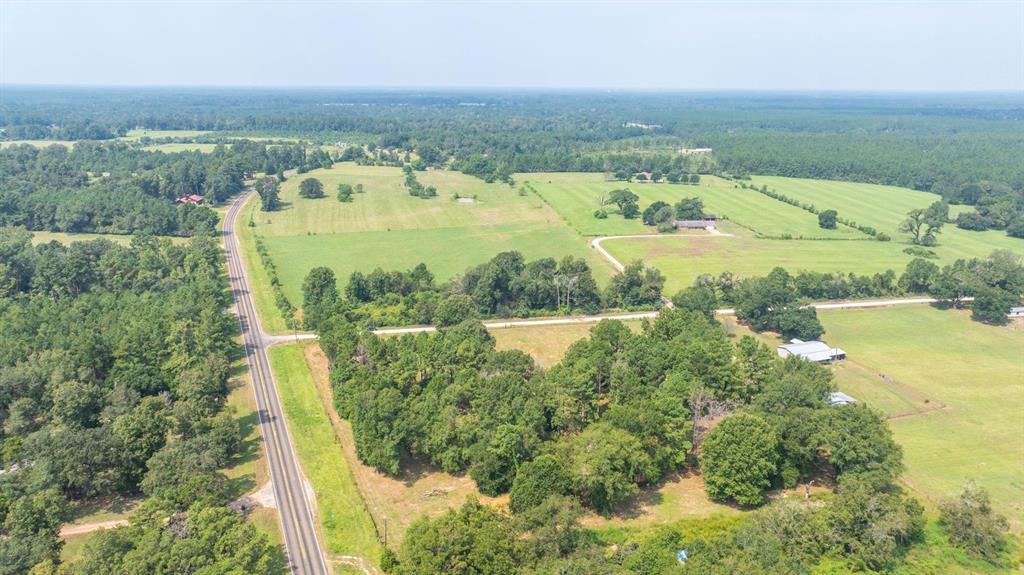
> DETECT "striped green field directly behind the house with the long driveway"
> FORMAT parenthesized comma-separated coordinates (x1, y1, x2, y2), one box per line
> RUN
(516, 173, 863, 238)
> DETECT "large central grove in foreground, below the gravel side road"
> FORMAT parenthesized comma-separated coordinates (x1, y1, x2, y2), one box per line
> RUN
(321, 309, 900, 513)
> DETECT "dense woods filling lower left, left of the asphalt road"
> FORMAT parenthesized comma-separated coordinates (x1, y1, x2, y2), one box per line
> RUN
(0, 228, 280, 573)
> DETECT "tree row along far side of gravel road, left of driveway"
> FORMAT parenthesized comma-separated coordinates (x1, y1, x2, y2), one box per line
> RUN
(303, 252, 665, 329)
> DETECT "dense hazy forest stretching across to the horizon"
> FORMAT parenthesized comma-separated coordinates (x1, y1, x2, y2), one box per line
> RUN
(0, 87, 1024, 194)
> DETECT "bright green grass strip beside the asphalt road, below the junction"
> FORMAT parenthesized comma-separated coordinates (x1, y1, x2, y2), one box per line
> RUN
(269, 343, 381, 563)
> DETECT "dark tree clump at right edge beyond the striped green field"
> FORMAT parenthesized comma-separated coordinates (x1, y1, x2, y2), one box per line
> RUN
(947, 182, 1024, 237)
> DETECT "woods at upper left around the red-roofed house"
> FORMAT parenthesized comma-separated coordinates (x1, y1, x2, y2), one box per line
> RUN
(0, 140, 330, 236)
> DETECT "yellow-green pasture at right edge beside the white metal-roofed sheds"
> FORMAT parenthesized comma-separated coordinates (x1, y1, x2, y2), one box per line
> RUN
(819, 306, 1024, 529)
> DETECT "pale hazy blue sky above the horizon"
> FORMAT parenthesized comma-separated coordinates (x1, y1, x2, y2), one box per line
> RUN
(0, 0, 1024, 91)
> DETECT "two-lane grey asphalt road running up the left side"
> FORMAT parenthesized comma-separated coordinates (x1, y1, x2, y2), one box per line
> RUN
(222, 190, 330, 575)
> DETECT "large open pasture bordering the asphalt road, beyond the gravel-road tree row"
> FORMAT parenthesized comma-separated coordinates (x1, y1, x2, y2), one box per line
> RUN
(253, 163, 613, 302)
